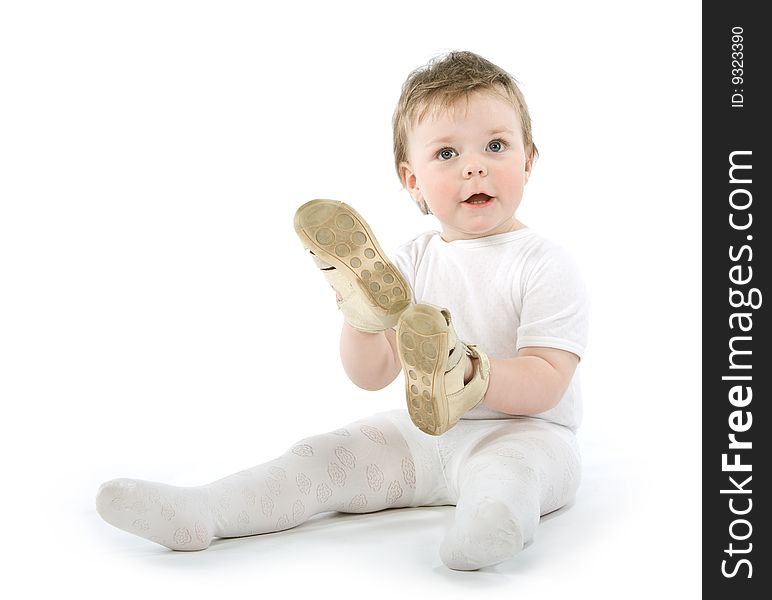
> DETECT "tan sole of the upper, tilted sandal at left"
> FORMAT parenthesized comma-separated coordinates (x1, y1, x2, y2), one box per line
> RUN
(295, 200, 410, 318)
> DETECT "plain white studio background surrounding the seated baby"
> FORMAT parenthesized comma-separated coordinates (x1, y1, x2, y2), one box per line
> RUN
(0, 0, 701, 598)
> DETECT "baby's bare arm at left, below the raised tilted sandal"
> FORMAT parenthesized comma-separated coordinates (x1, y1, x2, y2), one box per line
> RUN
(340, 321, 402, 391)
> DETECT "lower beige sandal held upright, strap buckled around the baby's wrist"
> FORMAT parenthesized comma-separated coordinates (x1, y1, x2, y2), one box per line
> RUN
(397, 304, 490, 435)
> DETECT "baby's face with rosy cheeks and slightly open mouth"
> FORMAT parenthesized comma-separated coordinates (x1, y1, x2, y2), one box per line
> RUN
(401, 92, 531, 241)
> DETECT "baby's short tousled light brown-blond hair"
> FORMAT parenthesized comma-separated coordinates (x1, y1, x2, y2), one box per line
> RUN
(392, 51, 539, 213)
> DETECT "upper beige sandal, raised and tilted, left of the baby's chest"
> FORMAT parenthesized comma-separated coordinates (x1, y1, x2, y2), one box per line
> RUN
(295, 200, 411, 333)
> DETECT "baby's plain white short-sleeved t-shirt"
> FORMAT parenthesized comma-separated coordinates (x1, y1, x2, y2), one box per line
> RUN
(391, 228, 589, 430)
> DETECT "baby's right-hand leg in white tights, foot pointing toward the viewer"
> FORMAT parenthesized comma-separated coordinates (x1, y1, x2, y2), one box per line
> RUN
(440, 420, 579, 570)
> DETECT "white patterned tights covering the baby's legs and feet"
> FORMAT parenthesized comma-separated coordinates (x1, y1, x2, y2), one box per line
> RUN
(97, 411, 579, 570)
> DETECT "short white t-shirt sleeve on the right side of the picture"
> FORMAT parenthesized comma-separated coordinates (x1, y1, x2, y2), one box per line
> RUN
(517, 245, 589, 358)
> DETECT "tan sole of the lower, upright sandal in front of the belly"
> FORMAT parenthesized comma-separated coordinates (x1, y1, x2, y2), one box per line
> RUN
(397, 304, 450, 435)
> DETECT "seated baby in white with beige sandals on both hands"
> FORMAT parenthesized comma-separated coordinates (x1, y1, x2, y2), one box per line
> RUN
(97, 52, 588, 570)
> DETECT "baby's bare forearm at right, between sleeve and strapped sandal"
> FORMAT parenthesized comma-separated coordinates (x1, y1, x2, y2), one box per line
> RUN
(483, 347, 579, 415)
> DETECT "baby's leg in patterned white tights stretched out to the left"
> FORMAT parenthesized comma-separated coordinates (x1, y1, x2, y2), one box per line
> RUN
(97, 415, 420, 550)
